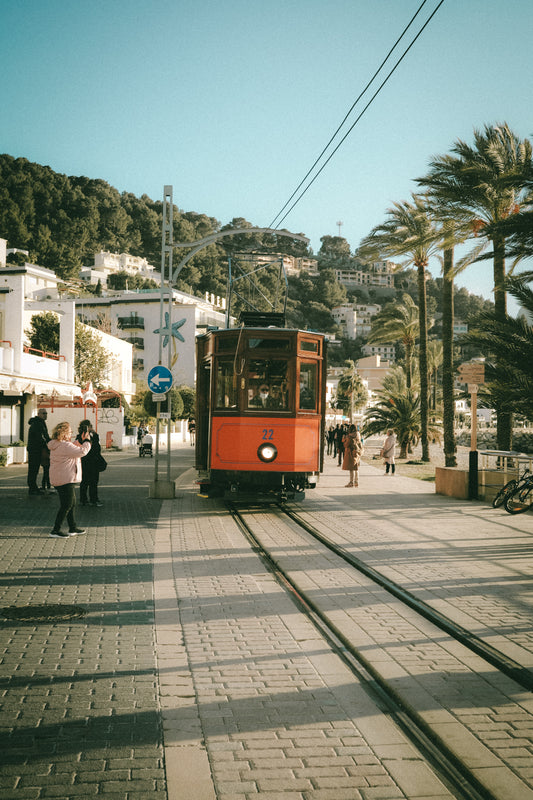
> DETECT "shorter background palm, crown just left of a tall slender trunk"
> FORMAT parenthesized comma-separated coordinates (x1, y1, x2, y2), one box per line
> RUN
(367, 294, 420, 389)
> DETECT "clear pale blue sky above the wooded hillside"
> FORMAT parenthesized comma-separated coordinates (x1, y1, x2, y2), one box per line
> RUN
(0, 0, 533, 310)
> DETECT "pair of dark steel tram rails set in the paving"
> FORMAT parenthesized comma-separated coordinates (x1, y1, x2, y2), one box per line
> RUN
(228, 506, 533, 800)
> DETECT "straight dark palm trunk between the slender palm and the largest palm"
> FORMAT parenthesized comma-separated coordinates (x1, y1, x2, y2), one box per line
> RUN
(442, 247, 457, 467)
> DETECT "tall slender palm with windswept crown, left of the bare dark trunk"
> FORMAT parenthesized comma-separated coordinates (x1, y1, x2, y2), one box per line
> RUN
(360, 195, 439, 461)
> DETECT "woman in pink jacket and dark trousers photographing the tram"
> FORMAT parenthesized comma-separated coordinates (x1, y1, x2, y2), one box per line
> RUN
(48, 422, 91, 539)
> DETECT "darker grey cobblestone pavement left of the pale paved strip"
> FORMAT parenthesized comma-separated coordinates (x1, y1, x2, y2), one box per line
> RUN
(0, 451, 190, 800)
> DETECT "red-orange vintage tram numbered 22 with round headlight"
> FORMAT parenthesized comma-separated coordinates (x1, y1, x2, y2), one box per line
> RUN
(196, 326, 326, 501)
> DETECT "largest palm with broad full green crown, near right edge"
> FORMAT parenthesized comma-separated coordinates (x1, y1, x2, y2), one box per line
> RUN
(417, 124, 532, 450)
